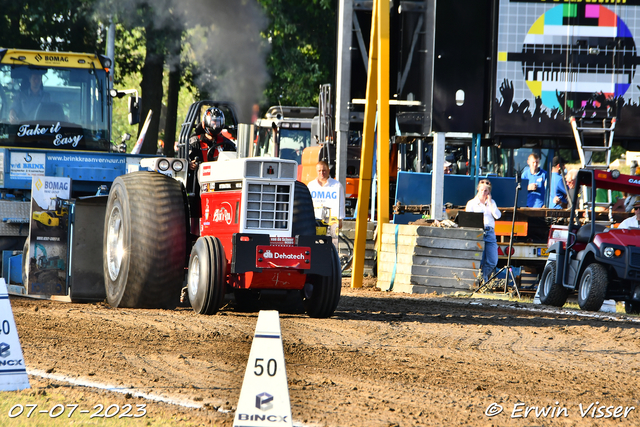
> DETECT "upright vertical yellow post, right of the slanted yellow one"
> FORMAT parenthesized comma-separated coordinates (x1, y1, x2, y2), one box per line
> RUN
(376, 0, 389, 271)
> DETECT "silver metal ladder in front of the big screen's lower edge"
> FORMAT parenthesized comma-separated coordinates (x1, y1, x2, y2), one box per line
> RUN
(569, 116, 616, 223)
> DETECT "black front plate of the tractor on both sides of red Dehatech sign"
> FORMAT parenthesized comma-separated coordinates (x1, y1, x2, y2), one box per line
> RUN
(230, 233, 333, 276)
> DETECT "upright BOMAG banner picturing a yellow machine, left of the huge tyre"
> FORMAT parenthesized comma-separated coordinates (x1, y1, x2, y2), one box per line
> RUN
(22, 176, 71, 295)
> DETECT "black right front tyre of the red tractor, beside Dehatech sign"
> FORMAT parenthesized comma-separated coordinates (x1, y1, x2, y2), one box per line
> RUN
(302, 245, 342, 318)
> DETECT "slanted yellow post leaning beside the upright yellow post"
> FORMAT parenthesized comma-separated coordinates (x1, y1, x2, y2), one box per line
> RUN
(351, 0, 378, 288)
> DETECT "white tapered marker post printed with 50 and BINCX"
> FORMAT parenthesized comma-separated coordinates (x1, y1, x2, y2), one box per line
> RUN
(233, 310, 293, 427)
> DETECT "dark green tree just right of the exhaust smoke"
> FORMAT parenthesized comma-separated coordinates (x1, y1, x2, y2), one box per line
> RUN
(258, 0, 336, 107)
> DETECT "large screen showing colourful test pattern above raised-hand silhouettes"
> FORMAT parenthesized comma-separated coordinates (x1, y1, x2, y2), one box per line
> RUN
(494, 0, 640, 137)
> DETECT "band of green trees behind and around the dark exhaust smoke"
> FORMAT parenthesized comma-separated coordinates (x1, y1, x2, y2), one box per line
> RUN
(0, 0, 336, 147)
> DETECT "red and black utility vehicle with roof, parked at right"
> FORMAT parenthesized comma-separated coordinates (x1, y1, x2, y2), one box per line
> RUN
(539, 170, 640, 314)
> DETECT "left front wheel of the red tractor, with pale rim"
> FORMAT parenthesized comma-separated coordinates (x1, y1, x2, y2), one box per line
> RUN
(187, 236, 227, 314)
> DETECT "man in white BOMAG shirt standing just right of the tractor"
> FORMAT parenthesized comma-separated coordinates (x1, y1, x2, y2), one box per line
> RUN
(307, 160, 344, 228)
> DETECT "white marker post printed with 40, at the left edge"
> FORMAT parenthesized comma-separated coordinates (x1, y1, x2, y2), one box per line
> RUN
(0, 278, 31, 391)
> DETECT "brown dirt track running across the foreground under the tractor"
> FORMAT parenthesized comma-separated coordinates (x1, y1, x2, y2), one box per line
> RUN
(5, 282, 640, 427)
